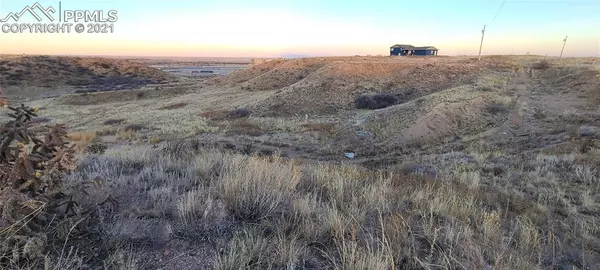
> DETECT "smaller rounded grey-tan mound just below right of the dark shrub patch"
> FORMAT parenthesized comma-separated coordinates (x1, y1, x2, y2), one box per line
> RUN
(361, 85, 514, 146)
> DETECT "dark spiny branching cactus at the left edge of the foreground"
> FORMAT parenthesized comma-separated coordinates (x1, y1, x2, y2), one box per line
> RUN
(0, 105, 103, 268)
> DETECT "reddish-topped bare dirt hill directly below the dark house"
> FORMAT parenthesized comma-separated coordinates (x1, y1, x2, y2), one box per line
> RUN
(221, 57, 508, 116)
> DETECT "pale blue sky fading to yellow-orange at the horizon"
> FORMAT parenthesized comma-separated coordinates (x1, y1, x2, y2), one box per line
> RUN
(0, 0, 600, 57)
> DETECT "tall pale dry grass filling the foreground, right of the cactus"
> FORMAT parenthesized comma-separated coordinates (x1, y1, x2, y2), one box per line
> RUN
(10, 138, 600, 269)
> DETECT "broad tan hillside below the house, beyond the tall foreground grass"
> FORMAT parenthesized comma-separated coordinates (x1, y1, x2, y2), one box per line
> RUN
(12, 56, 600, 158)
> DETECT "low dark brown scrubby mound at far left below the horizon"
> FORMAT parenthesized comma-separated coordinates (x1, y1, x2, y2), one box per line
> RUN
(0, 56, 172, 91)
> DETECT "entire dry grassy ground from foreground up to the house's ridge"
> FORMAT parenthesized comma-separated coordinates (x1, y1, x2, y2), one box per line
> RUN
(0, 56, 600, 269)
